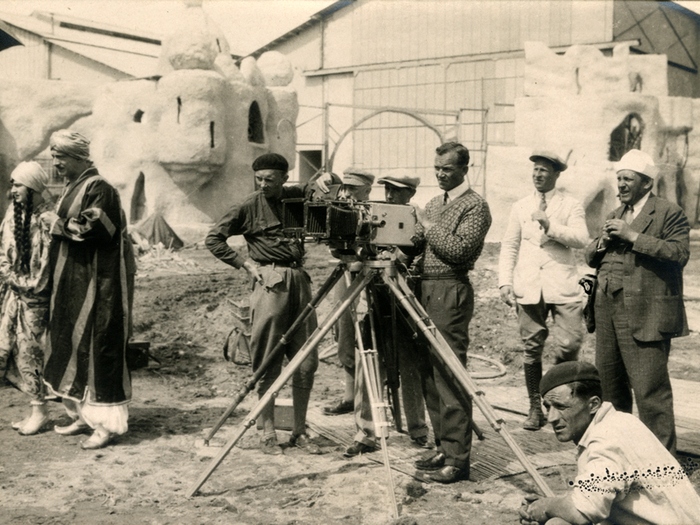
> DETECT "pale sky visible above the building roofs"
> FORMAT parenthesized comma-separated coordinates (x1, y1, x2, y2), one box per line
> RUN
(0, 0, 332, 54)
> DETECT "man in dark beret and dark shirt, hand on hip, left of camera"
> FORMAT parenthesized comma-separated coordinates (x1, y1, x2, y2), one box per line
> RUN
(205, 153, 330, 454)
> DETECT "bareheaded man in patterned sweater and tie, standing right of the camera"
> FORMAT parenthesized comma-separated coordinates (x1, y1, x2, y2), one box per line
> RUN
(415, 142, 491, 483)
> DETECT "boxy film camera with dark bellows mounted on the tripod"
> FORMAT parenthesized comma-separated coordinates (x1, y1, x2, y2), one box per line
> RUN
(282, 199, 417, 252)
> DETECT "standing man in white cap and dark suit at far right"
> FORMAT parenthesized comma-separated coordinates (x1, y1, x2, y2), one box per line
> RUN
(586, 150, 690, 453)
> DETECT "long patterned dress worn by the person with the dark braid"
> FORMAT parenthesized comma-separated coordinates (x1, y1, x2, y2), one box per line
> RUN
(0, 206, 51, 401)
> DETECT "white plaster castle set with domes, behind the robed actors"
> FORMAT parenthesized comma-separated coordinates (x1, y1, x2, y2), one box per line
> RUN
(0, 6, 299, 240)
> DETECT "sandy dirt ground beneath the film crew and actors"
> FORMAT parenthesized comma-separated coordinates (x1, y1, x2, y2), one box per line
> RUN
(0, 245, 700, 525)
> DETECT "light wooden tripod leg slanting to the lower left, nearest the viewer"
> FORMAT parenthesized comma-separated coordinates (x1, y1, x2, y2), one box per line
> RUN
(186, 273, 373, 498)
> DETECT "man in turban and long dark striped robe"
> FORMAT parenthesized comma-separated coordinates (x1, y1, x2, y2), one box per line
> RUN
(44, 130, 135, 449)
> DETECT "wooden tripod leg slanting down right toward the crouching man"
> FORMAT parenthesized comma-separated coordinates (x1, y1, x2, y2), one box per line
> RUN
(382, 273, 554, 497)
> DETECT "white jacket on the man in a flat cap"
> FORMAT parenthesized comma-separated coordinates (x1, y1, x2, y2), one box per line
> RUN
(498, 188, 590, 304)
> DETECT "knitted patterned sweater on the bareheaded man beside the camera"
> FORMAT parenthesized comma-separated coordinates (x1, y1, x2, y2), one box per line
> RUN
(416, 188, 491, 276)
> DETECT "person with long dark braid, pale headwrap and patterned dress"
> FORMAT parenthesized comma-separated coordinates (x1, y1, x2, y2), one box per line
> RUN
(0, 162, 51, 436)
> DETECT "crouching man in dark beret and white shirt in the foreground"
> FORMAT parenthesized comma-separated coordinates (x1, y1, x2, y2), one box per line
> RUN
(520, 361, 700, 525)
